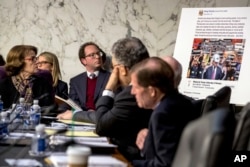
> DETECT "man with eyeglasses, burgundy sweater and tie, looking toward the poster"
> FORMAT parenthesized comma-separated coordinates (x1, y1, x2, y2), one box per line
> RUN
(57, 42, 110, 123)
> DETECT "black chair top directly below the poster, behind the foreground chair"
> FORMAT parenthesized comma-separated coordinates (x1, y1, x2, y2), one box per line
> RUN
(201, 86, 232, 115)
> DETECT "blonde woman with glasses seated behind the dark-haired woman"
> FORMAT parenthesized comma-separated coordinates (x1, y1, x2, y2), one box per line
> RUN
(36, 52, 68, 99)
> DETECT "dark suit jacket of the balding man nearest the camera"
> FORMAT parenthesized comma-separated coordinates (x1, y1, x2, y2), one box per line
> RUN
(132, 91, 195, 167)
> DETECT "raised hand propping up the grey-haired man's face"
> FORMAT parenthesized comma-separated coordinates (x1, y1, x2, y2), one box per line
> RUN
(105, 67, 119, 91)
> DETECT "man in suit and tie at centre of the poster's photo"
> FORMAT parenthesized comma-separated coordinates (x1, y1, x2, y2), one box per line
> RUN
(202, 54, 225, 80)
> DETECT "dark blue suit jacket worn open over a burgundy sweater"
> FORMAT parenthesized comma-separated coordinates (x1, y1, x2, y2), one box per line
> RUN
(69, 70, 110, 110)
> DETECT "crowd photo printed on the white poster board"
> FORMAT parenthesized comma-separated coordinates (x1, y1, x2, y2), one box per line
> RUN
(187, 38, 245, 81)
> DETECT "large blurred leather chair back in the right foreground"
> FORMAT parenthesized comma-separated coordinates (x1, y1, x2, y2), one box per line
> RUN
(172, 108, 235, 167)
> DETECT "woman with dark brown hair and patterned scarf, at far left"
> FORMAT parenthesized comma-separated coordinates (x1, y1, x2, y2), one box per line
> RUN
(0, 45, 54, 108)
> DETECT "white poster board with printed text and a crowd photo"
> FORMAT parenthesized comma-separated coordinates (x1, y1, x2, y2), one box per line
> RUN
(174, 7, 250, 105)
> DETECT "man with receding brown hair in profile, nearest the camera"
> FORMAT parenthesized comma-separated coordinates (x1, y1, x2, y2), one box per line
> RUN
(131, 57, 195, 167)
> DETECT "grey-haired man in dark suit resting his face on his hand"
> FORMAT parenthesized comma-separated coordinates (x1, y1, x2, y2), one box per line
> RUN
(96, 37, 152, 160)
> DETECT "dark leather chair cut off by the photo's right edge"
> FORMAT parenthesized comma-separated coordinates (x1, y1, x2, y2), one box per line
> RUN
(233, 103, 250, 151)
